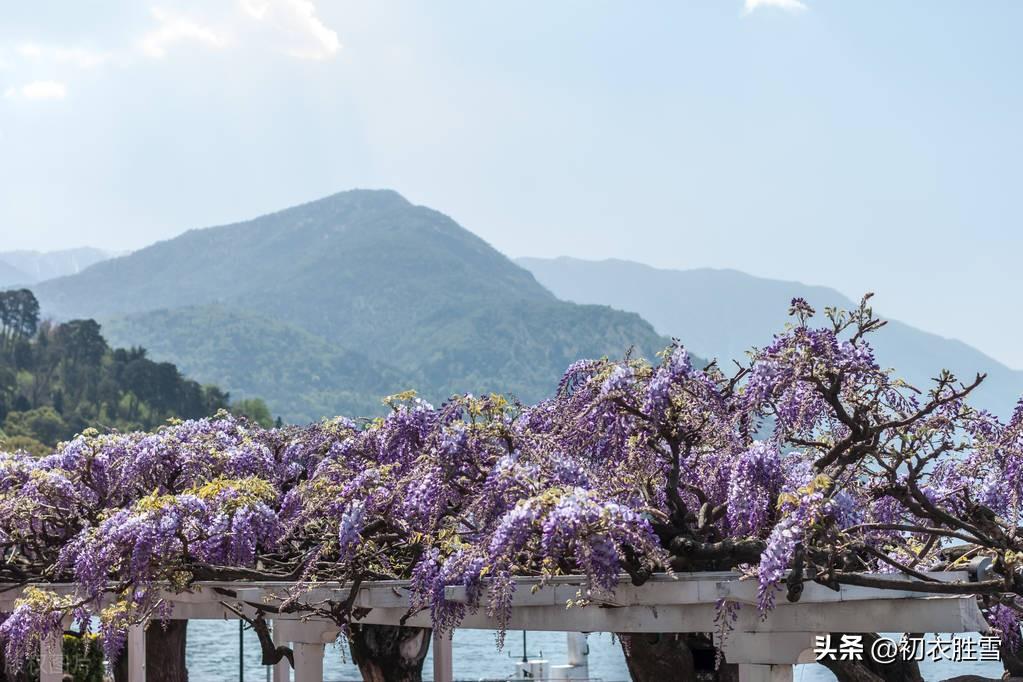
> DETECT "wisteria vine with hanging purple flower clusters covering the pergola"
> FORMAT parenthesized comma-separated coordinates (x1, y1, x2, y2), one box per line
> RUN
(0, 298, 1023, 674)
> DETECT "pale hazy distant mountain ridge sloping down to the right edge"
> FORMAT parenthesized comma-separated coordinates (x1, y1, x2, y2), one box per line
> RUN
(517, 258, 1023, 415)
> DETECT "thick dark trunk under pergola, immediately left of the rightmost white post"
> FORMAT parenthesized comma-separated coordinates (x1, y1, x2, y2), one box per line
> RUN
(618, 632, 739, 682)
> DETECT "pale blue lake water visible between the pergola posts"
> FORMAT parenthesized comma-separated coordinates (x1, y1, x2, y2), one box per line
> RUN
(187, 621, 1002, 682)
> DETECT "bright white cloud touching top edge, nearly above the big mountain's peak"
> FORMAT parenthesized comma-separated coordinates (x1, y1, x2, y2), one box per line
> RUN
(238, 0, 341, 59)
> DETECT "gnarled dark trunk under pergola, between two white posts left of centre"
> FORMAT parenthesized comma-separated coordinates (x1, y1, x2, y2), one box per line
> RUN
(349, 625, 433, 682)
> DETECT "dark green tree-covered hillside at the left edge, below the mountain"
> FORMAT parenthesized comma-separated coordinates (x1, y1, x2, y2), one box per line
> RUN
(0, 289, 251, 455)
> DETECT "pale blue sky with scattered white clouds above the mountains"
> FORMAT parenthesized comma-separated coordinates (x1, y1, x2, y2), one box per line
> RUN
(0, 0, 1023, 368)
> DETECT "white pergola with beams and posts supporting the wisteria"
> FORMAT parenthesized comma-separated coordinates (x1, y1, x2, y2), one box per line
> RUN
(0, 571, 988, 682)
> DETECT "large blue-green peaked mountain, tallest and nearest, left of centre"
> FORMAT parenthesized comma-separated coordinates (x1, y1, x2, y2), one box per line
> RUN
(34, 190, 667, 421)
